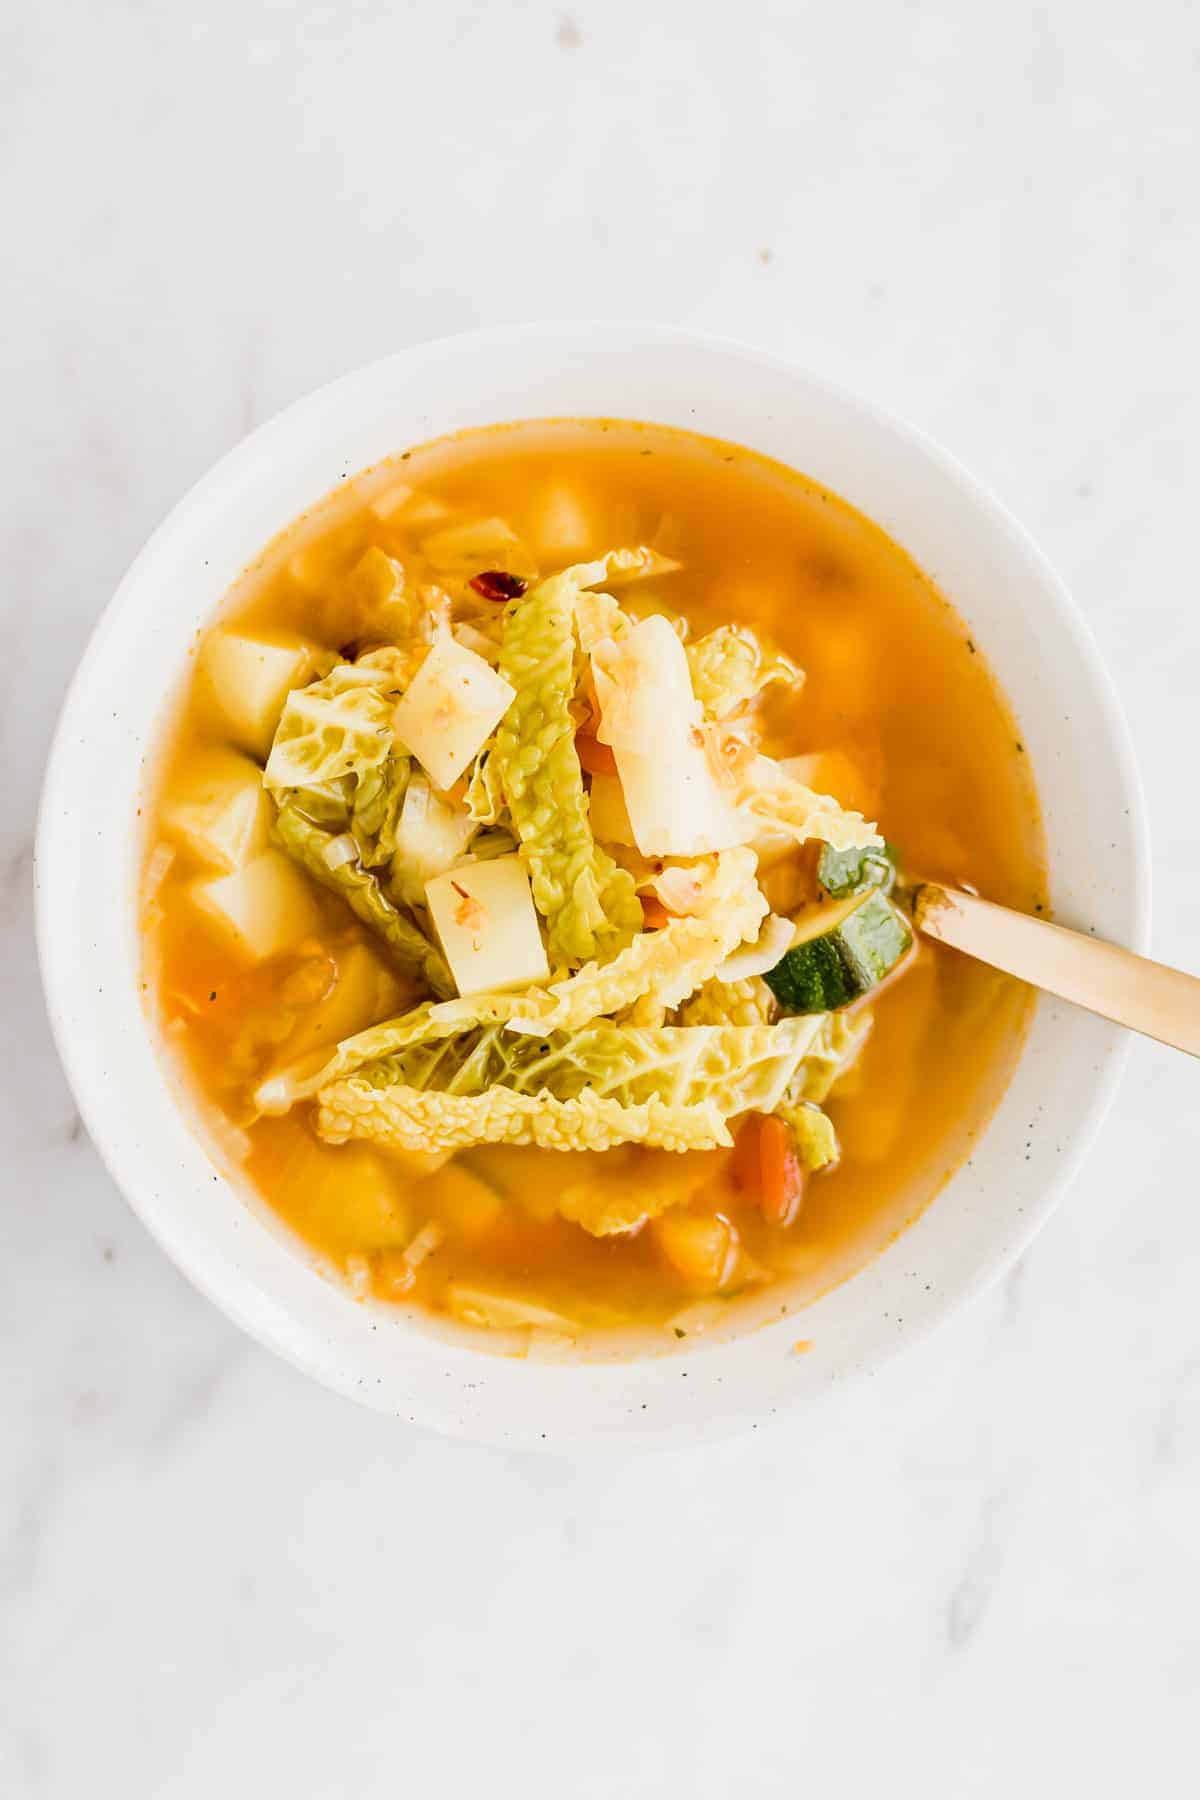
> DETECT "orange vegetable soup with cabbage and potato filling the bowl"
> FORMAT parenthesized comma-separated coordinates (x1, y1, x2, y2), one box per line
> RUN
(142, 419, 1045, 1350)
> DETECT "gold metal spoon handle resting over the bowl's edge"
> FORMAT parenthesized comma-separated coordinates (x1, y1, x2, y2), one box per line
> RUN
(914, 882, 1200, 1057)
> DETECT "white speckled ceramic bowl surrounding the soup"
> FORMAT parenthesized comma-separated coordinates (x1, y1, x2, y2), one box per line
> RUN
(36, 324, 1148, 1447)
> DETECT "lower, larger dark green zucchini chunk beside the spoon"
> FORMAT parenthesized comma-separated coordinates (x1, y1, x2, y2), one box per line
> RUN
(763, 887, 912, 1013)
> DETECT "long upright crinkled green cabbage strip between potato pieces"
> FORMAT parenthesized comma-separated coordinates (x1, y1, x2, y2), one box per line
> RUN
(488, 563, 642, 963)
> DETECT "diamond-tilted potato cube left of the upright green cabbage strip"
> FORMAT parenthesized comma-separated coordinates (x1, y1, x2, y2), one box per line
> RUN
(392, 637, 516, 788)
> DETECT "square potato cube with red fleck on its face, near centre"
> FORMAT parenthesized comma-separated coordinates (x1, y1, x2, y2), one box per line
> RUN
(425, 857, 551, 994)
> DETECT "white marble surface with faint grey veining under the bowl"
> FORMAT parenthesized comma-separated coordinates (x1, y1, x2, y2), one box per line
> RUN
(0, 0, 1200, 1800)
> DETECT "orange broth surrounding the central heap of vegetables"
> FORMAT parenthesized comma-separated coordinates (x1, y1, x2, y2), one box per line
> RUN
(146, 421, 1045, 1346)
